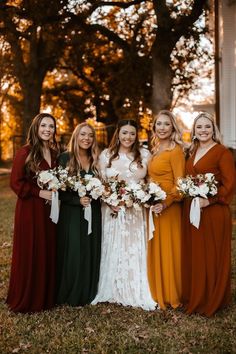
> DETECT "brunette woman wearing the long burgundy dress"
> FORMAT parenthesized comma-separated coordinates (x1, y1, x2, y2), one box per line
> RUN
(6, 113, 57, 313)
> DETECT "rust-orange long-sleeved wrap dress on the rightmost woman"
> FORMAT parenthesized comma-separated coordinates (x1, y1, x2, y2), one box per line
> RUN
(182, 144, 235, 316)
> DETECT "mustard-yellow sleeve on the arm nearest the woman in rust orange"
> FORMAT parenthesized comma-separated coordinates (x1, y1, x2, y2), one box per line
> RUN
(164, 148, 185, 206)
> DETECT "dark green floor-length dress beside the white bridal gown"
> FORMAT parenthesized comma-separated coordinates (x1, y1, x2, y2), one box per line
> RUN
(56, 153, 101, 306)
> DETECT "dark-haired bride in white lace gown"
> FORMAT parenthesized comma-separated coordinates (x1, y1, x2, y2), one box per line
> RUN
(92, 120, 157, 310)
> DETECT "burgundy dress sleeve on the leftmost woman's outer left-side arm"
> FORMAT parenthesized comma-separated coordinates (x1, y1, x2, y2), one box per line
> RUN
(10, 147, 40, 199)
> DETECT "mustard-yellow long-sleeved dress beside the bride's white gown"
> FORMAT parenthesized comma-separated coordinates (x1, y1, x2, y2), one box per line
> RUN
(148, 145, 185, 309)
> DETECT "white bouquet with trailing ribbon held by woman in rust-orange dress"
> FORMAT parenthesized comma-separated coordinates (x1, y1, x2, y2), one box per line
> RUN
(177, 173, 217, 229)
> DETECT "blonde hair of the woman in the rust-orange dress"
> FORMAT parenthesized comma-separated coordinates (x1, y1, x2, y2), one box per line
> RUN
(189, 112, 222, 155)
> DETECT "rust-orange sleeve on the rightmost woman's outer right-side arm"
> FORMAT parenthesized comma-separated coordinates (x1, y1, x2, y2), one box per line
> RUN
(208, 149, 235, 204)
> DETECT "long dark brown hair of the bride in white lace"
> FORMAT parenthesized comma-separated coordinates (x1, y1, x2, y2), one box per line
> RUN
(108, 119, 142, 167)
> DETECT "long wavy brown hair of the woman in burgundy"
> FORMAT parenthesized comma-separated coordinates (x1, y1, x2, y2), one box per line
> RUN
(25, 113, 59, 174)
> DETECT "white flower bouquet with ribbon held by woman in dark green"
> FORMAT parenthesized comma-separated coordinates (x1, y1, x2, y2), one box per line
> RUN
(67, 174, 104, 235)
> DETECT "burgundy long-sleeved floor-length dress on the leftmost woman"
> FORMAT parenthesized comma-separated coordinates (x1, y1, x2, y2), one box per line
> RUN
(6, 146, 56, 313)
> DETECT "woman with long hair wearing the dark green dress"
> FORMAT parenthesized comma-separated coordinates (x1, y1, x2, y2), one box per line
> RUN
(56, 123, 101, 306)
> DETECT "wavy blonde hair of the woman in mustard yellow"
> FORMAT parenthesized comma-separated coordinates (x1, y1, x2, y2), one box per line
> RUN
(151, 110, 184, 155)
